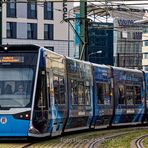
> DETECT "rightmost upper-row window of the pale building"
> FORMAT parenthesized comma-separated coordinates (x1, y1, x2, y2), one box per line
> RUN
(44, 2, 53, 20)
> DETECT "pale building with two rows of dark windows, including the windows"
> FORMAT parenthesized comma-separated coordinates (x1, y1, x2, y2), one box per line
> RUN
(2, 0, 74, 57)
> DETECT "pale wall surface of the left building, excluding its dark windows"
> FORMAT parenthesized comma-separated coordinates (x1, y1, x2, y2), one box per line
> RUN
(2, 0, 74, 57)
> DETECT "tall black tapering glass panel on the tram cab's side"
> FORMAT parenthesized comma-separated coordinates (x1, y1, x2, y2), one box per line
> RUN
(33, 70, 49, 133)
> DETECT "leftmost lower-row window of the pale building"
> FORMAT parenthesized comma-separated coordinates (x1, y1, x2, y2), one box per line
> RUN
(7, 22, 16, 38)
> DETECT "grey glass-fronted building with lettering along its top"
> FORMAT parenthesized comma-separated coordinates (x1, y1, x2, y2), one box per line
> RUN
(114, 18, 143, 69)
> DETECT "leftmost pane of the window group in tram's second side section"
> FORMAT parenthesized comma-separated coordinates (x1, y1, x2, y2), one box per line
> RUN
(71, 80, 78, 105)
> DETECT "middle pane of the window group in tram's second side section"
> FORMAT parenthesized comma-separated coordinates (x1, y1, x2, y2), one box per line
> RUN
(78, 82, 85, 105)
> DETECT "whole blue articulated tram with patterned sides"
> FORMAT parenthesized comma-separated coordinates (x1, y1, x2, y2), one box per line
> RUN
(0, 45, 148, 137)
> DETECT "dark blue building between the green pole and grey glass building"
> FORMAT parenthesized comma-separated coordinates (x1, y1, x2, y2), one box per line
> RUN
(87, 22, 113, 65)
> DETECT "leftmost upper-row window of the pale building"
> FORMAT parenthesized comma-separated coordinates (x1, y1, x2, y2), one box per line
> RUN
(7, 0, 16, 17)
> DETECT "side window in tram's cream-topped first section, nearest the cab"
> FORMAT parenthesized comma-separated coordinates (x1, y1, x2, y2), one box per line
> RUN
(53, 76, 65, 104)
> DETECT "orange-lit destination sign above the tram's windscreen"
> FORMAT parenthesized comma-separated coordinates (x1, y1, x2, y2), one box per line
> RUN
(0, 56, 24, 63)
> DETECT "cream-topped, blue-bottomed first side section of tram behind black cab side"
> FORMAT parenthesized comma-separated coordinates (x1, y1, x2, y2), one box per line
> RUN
(46, 52, 68, 136)
